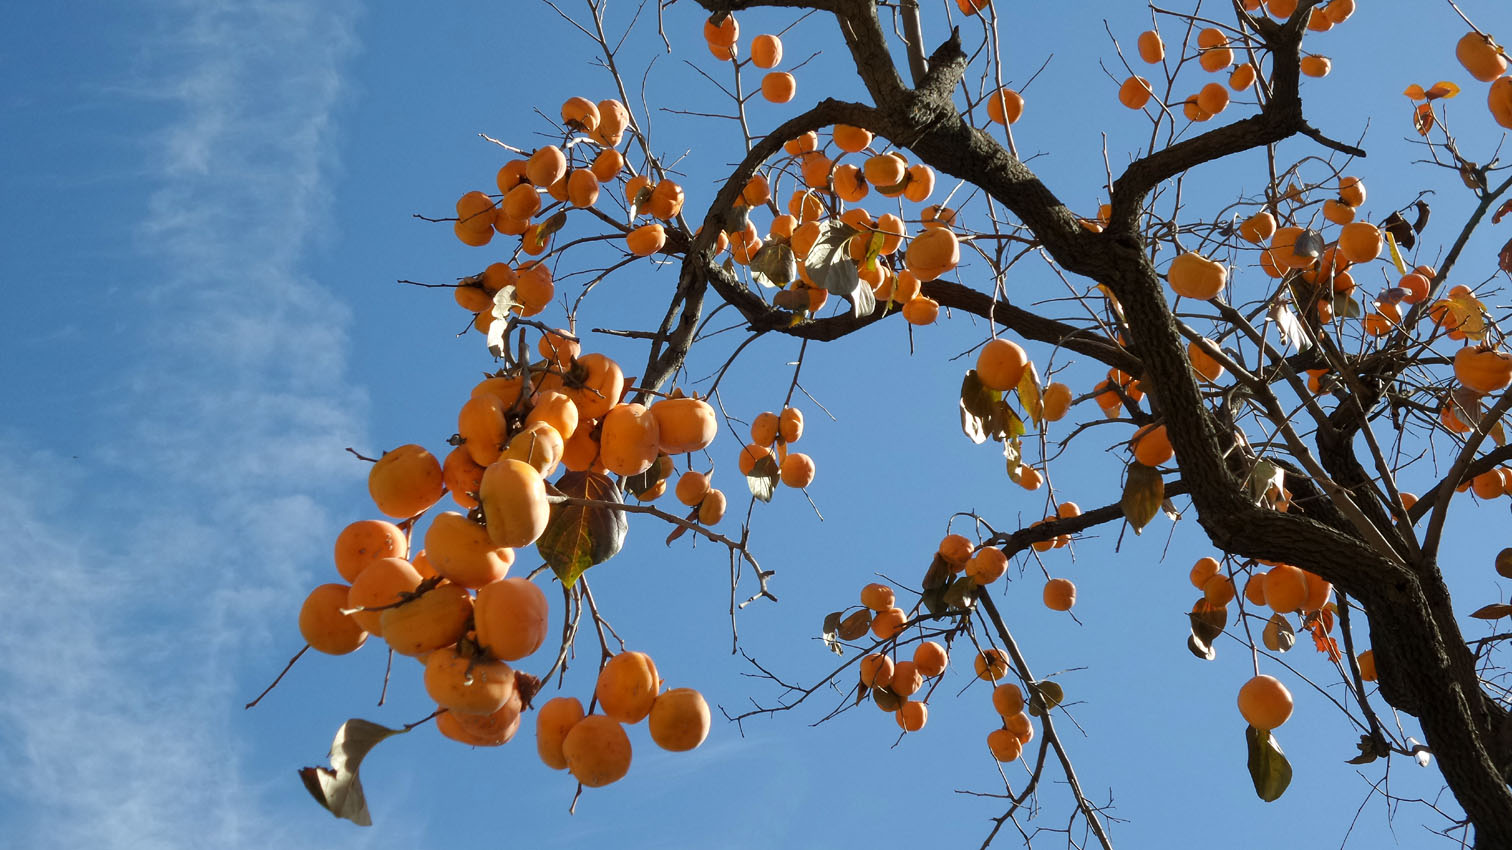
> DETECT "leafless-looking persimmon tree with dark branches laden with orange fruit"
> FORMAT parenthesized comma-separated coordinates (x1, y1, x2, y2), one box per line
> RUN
(250, 0, 1512, 847)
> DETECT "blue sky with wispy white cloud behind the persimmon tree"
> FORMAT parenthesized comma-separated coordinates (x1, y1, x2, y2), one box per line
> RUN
(0, 0, 1512, 850)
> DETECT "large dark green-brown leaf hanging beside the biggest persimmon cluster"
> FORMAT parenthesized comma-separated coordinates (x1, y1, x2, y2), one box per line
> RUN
(535, 472, 631, 587)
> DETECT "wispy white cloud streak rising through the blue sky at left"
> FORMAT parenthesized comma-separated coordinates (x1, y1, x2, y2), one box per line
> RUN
(0, 0, 384, 848)
